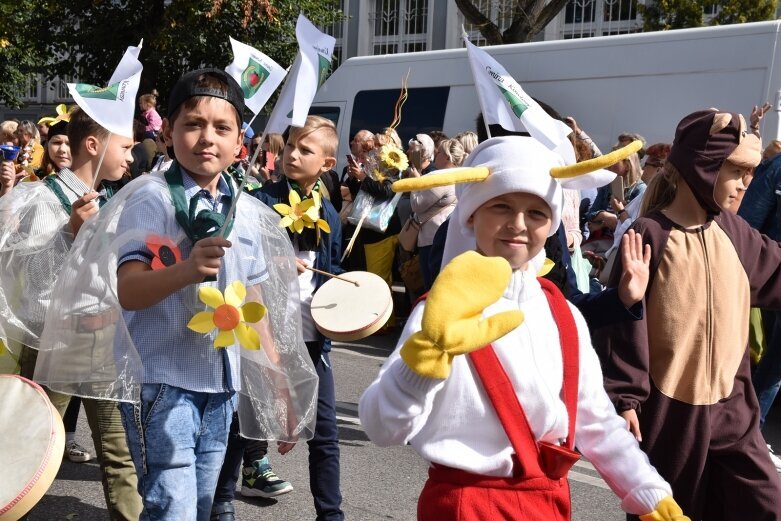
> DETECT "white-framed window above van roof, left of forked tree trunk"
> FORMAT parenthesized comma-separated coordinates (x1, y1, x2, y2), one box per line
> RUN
(370, 0, 429, 55)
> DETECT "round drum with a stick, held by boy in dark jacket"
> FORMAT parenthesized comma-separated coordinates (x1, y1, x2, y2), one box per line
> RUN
(312, 271, 393, 342)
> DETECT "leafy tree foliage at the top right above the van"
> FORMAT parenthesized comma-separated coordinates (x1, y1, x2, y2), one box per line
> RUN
(637, 0, 776, 31)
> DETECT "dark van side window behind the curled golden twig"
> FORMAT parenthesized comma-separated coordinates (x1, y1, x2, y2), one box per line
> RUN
(350, 87, 450, 144)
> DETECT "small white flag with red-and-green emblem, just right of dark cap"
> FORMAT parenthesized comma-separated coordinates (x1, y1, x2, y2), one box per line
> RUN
(225, 38, 287, 114)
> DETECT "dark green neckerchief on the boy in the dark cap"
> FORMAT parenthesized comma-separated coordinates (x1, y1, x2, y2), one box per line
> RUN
(165, 160, 236, 244)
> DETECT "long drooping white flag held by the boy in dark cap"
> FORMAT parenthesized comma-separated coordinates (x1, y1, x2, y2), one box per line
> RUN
(265, 14, 336, 134)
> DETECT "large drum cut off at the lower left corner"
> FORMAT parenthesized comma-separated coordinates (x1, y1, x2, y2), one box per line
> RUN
(0, 374, 65, 521)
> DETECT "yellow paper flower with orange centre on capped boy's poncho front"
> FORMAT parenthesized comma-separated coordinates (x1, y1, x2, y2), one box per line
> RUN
(187, 280, 266, 349)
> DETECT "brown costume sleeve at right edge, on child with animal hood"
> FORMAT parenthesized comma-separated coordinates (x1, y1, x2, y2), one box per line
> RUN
(715, 212, 781, 309)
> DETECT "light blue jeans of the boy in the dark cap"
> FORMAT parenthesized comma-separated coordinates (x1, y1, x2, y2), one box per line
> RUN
(120, 384, 236, 521)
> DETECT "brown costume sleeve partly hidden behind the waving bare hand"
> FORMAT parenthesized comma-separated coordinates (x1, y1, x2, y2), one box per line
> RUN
(594, 213, 669, 412)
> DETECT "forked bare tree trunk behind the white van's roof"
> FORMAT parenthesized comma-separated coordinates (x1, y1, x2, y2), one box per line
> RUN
(456, 0, 569, 45)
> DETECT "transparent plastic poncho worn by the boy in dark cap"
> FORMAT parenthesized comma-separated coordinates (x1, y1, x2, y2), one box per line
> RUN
(35, 174, 317, 441)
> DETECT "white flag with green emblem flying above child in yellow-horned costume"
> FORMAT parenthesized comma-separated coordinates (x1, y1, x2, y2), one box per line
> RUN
(464, 33, 575, 164)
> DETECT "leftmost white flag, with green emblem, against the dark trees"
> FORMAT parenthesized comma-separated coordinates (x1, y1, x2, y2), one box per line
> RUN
(68, 40, 144, 139)
